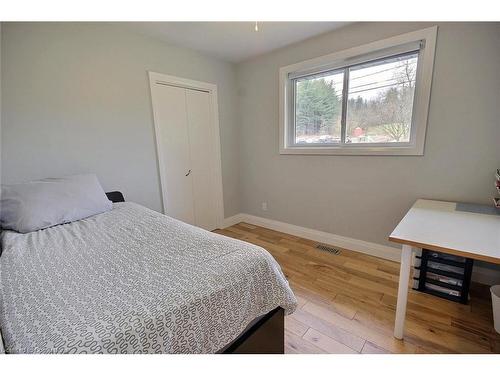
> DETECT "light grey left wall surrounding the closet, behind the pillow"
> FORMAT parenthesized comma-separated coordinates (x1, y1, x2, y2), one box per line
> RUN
(1, 23, 240, 216)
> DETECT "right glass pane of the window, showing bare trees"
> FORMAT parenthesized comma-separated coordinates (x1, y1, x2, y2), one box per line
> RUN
(346, 52, 418, 143)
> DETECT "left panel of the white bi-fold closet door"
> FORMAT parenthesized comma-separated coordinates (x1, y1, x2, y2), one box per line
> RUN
(153, 84, 196, 225)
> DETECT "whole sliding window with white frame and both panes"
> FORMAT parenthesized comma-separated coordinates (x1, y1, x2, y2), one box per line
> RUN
(280, 28, 437, 155)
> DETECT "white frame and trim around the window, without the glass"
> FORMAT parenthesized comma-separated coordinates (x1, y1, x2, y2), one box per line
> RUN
(279, 26, 437, 155)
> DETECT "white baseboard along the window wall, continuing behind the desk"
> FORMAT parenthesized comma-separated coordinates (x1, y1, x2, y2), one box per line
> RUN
(223, 213, 500, 285)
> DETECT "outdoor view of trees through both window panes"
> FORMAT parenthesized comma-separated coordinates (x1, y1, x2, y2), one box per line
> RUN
(295, 53, 418, 144)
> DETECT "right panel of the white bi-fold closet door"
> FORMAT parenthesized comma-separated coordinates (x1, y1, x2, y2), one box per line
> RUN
(186, 89, 217, 230)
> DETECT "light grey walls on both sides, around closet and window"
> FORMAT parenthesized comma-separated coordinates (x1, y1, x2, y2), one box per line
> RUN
(1, 23, 500, 276)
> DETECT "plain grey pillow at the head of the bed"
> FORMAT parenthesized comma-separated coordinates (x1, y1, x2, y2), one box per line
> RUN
(0, 174, 113, 233)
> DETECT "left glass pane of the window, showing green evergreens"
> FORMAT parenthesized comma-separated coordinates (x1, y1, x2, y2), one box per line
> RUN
(294, 71, 344, 145)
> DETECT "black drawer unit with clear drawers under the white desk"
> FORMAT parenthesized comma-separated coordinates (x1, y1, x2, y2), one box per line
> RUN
(414, 249, 474, 304)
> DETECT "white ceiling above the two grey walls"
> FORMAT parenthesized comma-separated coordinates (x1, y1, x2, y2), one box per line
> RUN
(122, 22, 348, 62)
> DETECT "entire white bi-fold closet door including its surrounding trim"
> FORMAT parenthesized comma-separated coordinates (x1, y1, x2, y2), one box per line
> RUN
(150, 73, 222, 230)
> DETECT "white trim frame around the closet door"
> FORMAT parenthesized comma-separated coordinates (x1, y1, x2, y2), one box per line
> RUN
(148, 71, 224, 228)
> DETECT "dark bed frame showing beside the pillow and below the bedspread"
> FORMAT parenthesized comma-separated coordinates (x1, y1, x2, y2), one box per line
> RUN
(106, 191, 285, 354)
